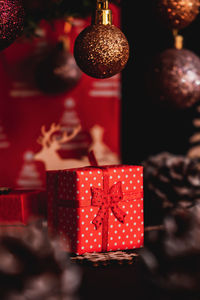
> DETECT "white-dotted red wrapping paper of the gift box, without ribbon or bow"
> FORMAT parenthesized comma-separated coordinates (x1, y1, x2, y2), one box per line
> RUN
(47, 165, 144, 254)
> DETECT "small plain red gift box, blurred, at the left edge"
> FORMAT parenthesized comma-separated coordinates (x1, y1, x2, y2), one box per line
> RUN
(0, 190, 47, 225)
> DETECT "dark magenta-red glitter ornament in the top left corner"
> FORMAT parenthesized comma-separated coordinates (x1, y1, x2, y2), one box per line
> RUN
(0, 0, 25, 50)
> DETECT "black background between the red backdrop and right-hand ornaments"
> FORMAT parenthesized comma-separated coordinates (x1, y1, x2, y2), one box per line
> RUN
(121, 0, 200, 164)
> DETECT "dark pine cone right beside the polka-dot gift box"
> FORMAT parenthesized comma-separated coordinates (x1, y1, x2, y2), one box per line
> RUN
(143, 152, 200, 225)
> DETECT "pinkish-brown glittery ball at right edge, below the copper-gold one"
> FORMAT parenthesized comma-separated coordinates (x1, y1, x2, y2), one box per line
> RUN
(149, 49, 200, 109)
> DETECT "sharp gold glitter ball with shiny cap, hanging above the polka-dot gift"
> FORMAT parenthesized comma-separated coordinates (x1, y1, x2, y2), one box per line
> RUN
(74, 0, 129, 79)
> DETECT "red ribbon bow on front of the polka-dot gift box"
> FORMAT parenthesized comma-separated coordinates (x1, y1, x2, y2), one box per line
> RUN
(91, 181, 126, 229)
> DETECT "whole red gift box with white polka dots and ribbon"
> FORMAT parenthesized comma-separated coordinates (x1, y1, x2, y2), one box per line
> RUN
(47, 165, 144, 254)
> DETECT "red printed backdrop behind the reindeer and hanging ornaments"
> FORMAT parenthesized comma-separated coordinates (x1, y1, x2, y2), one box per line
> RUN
(0, 6, 121, 188)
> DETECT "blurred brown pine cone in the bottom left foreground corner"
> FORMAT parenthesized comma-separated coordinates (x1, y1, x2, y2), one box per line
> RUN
(0, 225, 80, 300)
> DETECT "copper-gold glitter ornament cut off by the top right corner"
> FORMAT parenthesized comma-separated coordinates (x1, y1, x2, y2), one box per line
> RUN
(155, 0, 199, 29)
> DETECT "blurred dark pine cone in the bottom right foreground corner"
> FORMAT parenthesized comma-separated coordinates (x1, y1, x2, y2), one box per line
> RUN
(141, 204, 200, 300)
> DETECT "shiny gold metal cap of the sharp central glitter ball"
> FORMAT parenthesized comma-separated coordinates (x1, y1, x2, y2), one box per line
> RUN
(92, 0, 112, 25)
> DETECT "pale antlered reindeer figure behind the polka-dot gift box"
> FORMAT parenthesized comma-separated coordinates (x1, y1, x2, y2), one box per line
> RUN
(34, 123, 90, 170)
